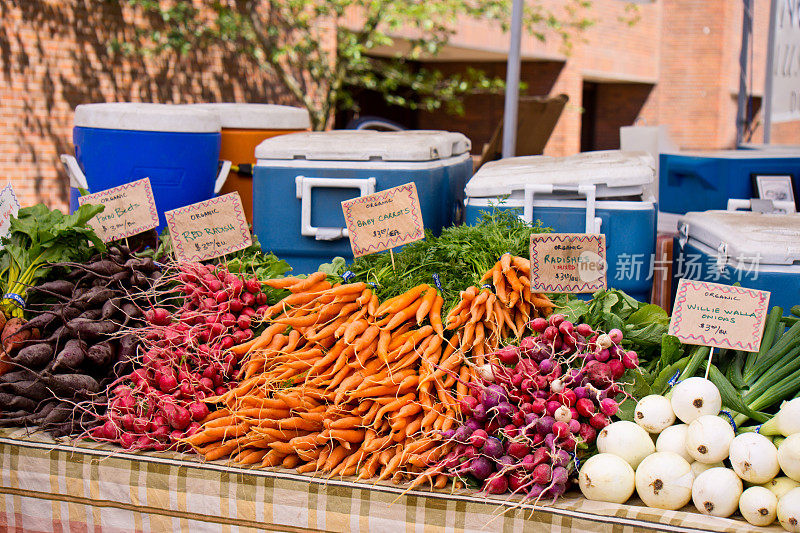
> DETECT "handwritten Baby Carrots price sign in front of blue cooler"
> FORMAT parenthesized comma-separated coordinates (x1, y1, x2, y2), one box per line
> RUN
(342, 183, 425, 257)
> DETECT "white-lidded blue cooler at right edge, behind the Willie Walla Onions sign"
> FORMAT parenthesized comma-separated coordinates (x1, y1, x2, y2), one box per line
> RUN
(672, 211, 800, 313)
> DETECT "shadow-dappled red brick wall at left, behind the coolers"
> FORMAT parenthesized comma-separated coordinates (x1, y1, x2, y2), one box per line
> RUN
(0, 0, 292, 208)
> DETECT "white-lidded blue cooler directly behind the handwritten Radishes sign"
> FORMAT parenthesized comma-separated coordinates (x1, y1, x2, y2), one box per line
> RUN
(466, 150, 660, 301)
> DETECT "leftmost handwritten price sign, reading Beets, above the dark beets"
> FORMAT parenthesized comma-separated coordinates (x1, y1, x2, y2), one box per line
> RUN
(78, 178, 158, 242)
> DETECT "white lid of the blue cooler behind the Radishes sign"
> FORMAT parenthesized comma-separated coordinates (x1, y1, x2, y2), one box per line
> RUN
(466, 150, 655, 198)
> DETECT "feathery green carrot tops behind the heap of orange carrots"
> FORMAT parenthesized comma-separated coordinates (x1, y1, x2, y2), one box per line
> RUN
(336, 209, 551, 309)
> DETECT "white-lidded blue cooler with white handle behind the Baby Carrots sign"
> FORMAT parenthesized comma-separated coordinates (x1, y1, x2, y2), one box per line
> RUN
(253, 130, 472, 273)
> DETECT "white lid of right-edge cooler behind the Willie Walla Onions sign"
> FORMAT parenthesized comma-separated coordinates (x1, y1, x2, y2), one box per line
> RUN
(678, 211, 800, 265)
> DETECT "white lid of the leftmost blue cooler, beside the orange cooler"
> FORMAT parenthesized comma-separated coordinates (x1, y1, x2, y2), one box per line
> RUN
(75, 102, 220, 133)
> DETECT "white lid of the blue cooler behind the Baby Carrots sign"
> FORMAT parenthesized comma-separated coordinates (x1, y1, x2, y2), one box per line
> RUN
(256, 130, 472, 161)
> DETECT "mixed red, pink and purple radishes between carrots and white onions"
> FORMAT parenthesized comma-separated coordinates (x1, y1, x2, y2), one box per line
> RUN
(438, 315, 635, 501)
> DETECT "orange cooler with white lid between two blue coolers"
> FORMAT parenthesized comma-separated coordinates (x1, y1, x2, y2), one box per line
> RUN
(193, 103, 311, 224)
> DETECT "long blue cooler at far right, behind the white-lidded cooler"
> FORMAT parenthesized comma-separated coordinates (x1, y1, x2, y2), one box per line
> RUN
(658, 148, 800, 214)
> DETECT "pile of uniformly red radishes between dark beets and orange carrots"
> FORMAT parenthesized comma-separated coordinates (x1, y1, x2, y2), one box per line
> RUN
(91, 263, 266, 450)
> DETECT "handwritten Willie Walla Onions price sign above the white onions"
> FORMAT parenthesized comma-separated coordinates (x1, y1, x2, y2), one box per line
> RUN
(669, 279, 770, 352)
